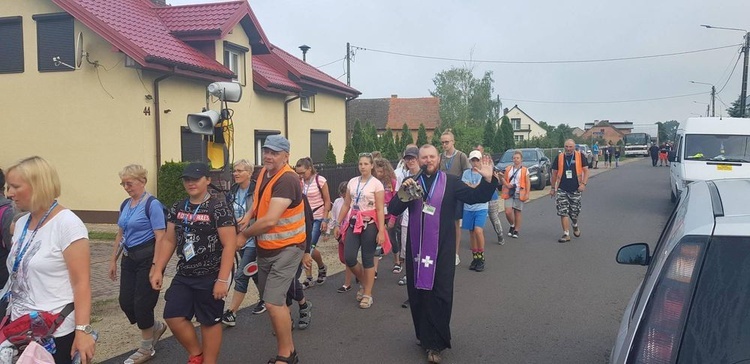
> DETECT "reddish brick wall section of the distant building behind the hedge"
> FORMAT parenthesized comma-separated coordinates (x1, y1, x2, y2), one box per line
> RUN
(388, 97, 440, 130)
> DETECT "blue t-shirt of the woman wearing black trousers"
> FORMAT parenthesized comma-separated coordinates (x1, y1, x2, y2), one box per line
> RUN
(117, 194, 167, 249)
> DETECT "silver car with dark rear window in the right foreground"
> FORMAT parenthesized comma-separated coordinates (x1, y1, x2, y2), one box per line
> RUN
(610, 179, 750, 364)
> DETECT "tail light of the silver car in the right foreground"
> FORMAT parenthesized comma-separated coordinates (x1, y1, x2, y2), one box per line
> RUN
(628, 242, 705, 364)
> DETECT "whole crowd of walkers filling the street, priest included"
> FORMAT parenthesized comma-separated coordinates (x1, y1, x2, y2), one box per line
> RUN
(0, 130, 588, 364)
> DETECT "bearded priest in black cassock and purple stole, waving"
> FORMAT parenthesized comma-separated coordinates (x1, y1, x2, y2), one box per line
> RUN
(388, 145, 498, 363)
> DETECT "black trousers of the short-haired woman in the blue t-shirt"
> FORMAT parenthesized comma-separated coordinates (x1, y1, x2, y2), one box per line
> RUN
(120, 249, 159, 330)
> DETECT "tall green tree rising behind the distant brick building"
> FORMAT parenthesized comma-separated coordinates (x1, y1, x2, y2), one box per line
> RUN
(430, 67, 500, 128)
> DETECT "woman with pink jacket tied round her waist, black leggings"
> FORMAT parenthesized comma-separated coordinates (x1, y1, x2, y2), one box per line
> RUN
(333, 153, 386, 308)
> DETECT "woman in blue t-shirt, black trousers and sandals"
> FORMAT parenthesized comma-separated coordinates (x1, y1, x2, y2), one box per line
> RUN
(109, 164, 167, 364)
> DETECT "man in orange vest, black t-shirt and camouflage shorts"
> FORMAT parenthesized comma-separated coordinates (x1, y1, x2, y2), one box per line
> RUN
(549, 139, 589, 243)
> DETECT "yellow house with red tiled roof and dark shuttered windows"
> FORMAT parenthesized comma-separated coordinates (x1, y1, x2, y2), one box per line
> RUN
(0, 0, 360, 222)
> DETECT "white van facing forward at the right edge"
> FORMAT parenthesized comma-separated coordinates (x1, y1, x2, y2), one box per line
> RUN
(669, 117, 750, 202)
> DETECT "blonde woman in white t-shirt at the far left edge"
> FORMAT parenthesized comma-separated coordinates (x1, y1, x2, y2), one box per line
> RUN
(7, 157, 95, 363)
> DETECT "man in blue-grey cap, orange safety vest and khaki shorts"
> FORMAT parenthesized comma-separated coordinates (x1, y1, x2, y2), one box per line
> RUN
(240, 135, 312, 363)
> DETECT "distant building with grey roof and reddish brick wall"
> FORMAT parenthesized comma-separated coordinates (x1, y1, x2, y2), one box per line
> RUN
(347, 95, 440, 140)
